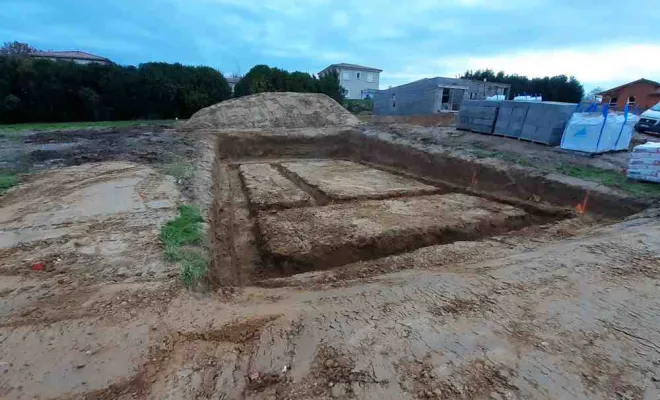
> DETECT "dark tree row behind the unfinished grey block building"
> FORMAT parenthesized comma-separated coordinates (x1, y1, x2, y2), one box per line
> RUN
(461, 69, 584, 103)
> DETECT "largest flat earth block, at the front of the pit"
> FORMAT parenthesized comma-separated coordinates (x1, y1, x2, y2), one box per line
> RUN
(257, 193, 531, 274)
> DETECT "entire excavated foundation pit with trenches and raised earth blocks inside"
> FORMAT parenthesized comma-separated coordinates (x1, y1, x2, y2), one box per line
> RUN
(211, 131, 645, 285)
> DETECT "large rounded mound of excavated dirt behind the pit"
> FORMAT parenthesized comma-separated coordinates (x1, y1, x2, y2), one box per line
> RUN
(184, 93, 359, 130)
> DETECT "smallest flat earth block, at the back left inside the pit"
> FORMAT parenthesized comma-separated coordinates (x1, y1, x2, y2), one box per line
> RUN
(240, 164, 313, 210)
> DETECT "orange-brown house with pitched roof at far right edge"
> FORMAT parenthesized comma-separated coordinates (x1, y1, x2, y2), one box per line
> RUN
(598, 78, 660, 110)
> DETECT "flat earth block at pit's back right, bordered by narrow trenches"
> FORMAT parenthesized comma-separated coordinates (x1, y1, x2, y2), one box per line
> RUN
(281, 160, 441, 200)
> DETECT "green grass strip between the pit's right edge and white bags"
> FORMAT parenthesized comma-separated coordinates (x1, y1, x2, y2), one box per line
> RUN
(557, 165, 660, 197)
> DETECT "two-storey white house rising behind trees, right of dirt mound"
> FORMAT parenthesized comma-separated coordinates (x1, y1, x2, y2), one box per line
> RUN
(318, 63, 383, 99)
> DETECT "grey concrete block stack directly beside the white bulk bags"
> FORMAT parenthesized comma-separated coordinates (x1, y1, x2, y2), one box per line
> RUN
(520, 101, 577, 146)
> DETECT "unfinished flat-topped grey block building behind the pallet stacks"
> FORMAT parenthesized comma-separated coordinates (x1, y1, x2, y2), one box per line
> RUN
(374, 77, 511, 115)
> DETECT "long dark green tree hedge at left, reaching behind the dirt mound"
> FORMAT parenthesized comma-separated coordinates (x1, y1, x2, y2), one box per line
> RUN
(0, 42, 343, 123)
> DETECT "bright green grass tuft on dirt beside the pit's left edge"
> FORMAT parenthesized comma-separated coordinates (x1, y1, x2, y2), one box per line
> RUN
(160, 205, 208, 288)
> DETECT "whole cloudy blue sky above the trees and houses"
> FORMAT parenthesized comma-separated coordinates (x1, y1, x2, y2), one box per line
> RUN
(0, 0, 660, 89)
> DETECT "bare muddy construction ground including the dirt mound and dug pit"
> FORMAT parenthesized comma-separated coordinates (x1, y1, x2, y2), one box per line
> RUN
(0, 93, 660, 400)
